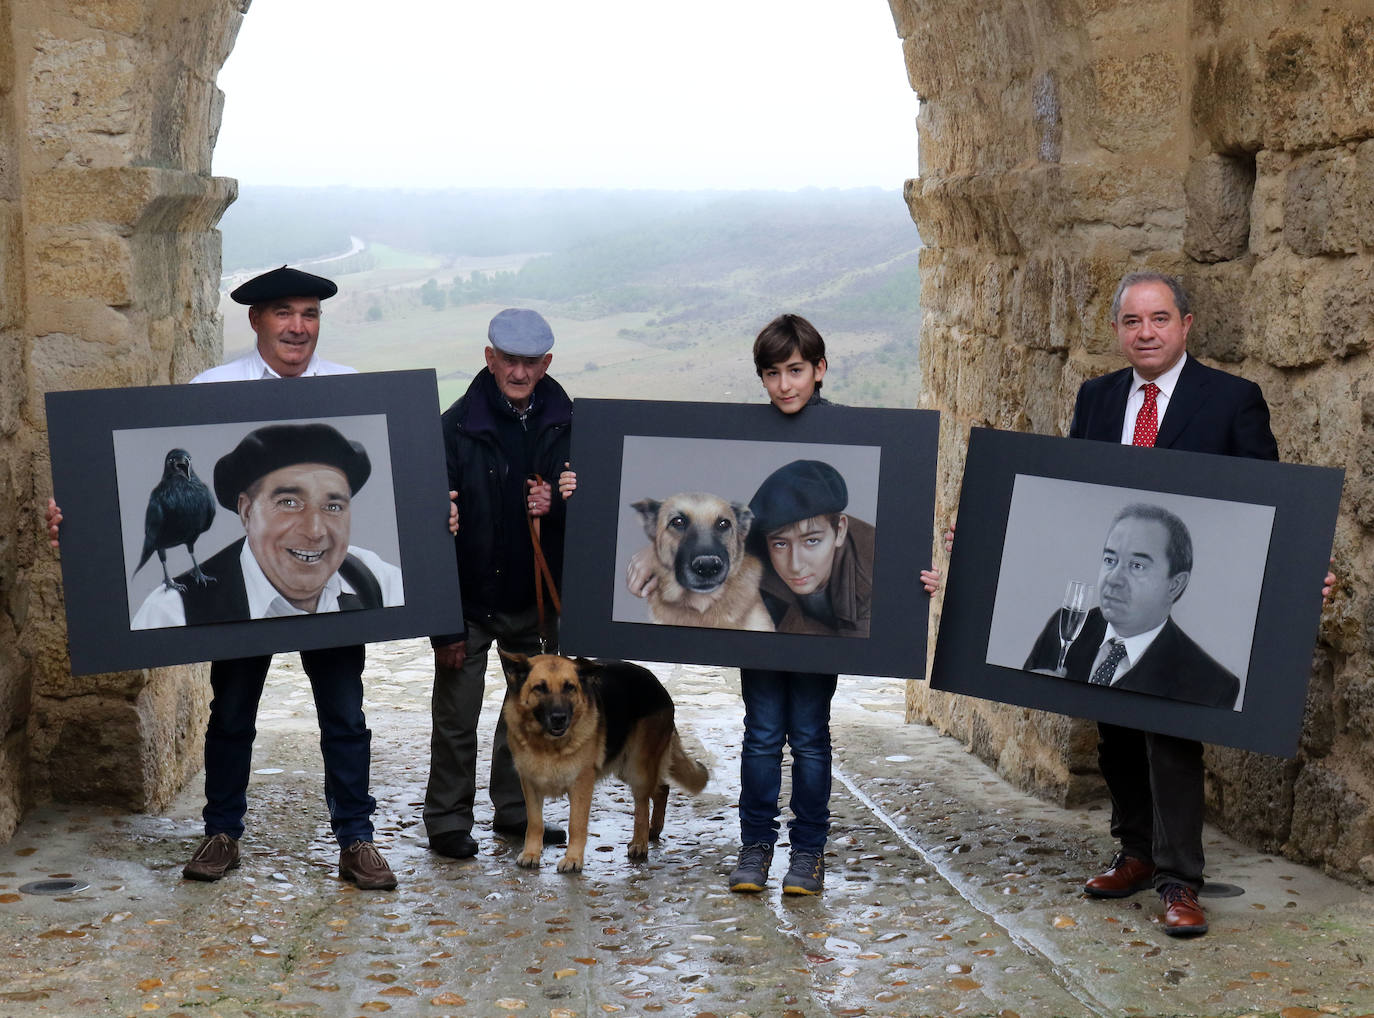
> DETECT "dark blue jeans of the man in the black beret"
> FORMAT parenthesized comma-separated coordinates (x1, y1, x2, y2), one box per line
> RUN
(202, 646, 376, 848)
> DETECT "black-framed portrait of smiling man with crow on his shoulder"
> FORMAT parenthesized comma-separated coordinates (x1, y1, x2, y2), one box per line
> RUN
(48, 371, 462, 675)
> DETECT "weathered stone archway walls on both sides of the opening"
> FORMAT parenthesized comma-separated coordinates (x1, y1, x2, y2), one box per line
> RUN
(0, 0, 1374, 878)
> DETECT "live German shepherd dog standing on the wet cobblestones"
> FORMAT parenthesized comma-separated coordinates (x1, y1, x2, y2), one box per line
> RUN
(499, 651, 710, 872)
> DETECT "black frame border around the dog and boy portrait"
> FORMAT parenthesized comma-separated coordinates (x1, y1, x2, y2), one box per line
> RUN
(561, 398, 940, 677)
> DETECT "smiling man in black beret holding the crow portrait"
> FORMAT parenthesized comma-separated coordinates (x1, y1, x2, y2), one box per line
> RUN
(48, 265, 396, 890)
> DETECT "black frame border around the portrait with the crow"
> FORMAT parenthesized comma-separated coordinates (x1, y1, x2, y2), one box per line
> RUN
(47, 370, 463, 675)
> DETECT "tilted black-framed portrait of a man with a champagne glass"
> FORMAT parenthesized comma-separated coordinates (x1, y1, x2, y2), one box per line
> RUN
(932, 430, 1342, 756)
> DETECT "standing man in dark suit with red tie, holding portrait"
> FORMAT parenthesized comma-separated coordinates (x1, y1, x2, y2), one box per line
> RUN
(1069, 272, 1278, 936)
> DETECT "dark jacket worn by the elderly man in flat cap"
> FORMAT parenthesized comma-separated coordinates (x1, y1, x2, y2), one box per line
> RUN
(433, 368, 573, 646)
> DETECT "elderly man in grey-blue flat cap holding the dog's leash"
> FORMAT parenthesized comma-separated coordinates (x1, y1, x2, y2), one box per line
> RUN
(425, 308, 573, 859)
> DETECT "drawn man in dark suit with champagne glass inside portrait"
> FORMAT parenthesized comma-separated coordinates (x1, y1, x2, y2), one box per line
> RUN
(1024, 503, 1241, 708)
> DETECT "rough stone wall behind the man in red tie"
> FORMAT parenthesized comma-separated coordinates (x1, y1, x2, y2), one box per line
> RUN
(890, 0, 1374, 879)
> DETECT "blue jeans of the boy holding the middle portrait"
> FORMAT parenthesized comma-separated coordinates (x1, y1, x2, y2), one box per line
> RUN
(739, 668, 835, 852)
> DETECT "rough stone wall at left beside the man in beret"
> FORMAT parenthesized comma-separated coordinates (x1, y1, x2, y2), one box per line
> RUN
(0, 0, 247, 841)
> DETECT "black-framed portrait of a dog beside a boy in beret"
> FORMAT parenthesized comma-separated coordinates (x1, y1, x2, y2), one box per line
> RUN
(562, 400, 938, 676)
